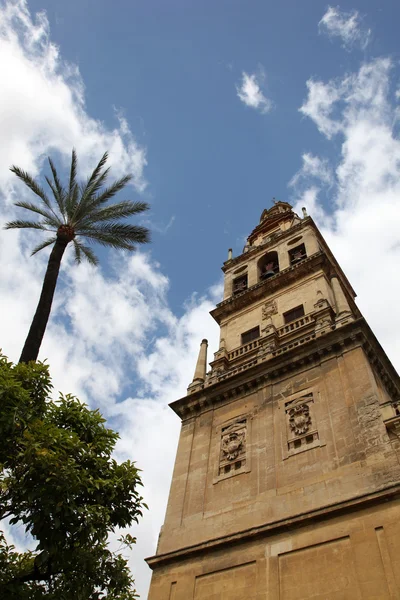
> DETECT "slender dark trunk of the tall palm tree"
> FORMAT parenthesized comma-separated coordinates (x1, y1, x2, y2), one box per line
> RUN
(19, 238, 68, 363)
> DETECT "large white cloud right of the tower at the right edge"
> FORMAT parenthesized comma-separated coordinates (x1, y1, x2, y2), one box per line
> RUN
(292, 58, 400, 368)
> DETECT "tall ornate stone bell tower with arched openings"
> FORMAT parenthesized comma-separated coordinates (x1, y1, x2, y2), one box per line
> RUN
(147, 202, 400, 600)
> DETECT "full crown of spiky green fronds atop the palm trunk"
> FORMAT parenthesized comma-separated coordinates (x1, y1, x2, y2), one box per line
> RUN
(9, 149, 150, 265)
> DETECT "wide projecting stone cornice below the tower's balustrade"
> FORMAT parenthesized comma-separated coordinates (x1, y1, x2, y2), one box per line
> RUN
(170, 317, 400, 421)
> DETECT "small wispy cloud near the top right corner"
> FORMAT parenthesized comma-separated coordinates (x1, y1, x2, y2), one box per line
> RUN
(318, 6, 371, 49)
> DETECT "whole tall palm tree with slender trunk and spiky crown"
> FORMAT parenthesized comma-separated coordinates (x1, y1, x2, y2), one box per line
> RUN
(5, 150, 150, 362)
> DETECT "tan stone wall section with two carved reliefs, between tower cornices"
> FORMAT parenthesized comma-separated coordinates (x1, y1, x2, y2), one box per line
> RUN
(158, 347, 400, 553)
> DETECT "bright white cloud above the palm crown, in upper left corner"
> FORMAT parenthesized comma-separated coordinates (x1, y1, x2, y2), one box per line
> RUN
(0, 0, 146, 191)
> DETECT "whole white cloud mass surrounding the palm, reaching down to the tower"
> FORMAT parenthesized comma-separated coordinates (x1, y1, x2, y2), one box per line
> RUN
(0, 0, 221, 598)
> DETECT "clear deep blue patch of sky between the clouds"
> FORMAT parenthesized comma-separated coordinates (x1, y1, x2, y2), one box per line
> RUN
(24, 0, 400, 312)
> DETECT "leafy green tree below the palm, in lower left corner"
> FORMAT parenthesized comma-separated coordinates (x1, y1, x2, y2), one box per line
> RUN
(0, 355, 145, 600)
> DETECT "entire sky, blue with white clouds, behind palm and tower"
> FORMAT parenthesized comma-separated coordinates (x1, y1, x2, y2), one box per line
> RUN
(0, 0, 400, 598)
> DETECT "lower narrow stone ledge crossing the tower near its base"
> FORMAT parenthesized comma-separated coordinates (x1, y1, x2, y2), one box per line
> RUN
(146, 484, 400, 569)
